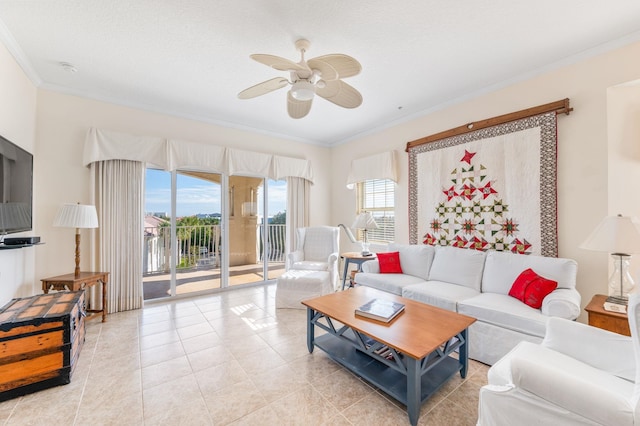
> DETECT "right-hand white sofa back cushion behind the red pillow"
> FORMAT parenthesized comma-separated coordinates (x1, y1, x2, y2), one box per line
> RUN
(482, 251, 578, 294)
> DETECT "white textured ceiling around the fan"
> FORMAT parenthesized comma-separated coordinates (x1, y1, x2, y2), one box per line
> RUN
(0, 0, 640, 145)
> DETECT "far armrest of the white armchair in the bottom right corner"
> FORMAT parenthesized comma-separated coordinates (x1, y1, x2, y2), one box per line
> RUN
(542, 317, 636, 382)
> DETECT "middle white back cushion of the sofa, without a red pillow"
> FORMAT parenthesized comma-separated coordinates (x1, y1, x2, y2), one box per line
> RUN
(429, 246, 488, 291)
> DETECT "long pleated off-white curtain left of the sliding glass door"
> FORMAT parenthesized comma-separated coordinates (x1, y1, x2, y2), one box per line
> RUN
(91, 160, 145, 313)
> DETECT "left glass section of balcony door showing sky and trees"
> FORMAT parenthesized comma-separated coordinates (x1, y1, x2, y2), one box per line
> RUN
(143, 169, 222, 300)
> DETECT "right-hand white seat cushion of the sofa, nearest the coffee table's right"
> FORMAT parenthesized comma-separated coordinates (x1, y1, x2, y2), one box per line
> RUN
(458, 293, 547, 337)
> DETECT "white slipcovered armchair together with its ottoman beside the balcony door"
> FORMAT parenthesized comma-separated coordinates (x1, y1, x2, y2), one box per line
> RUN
(276, 226, 340, 309)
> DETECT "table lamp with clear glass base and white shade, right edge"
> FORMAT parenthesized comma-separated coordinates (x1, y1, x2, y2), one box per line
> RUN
(580, 215, 640, 305)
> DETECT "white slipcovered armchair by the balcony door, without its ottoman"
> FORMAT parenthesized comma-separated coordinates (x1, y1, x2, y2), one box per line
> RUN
(288, 226, 340, 289)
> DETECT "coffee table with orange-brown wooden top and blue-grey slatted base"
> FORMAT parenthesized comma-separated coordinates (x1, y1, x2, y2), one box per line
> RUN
(302, 287, 475, 425)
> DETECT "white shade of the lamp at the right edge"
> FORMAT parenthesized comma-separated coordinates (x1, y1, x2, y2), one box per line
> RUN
(580, 215, 640, 254)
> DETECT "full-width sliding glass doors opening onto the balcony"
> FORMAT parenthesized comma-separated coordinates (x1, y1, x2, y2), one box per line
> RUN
(143, 169, 286, 300)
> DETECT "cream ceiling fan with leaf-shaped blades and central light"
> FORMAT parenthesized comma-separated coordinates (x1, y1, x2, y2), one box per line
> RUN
(238, 39, 362, 118)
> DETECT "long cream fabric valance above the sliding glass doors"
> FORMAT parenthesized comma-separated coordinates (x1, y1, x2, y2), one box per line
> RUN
(83, 128, 313, 182)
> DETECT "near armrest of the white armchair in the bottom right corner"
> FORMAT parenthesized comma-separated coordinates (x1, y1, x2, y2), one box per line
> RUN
(511, 351, 634, 425)
